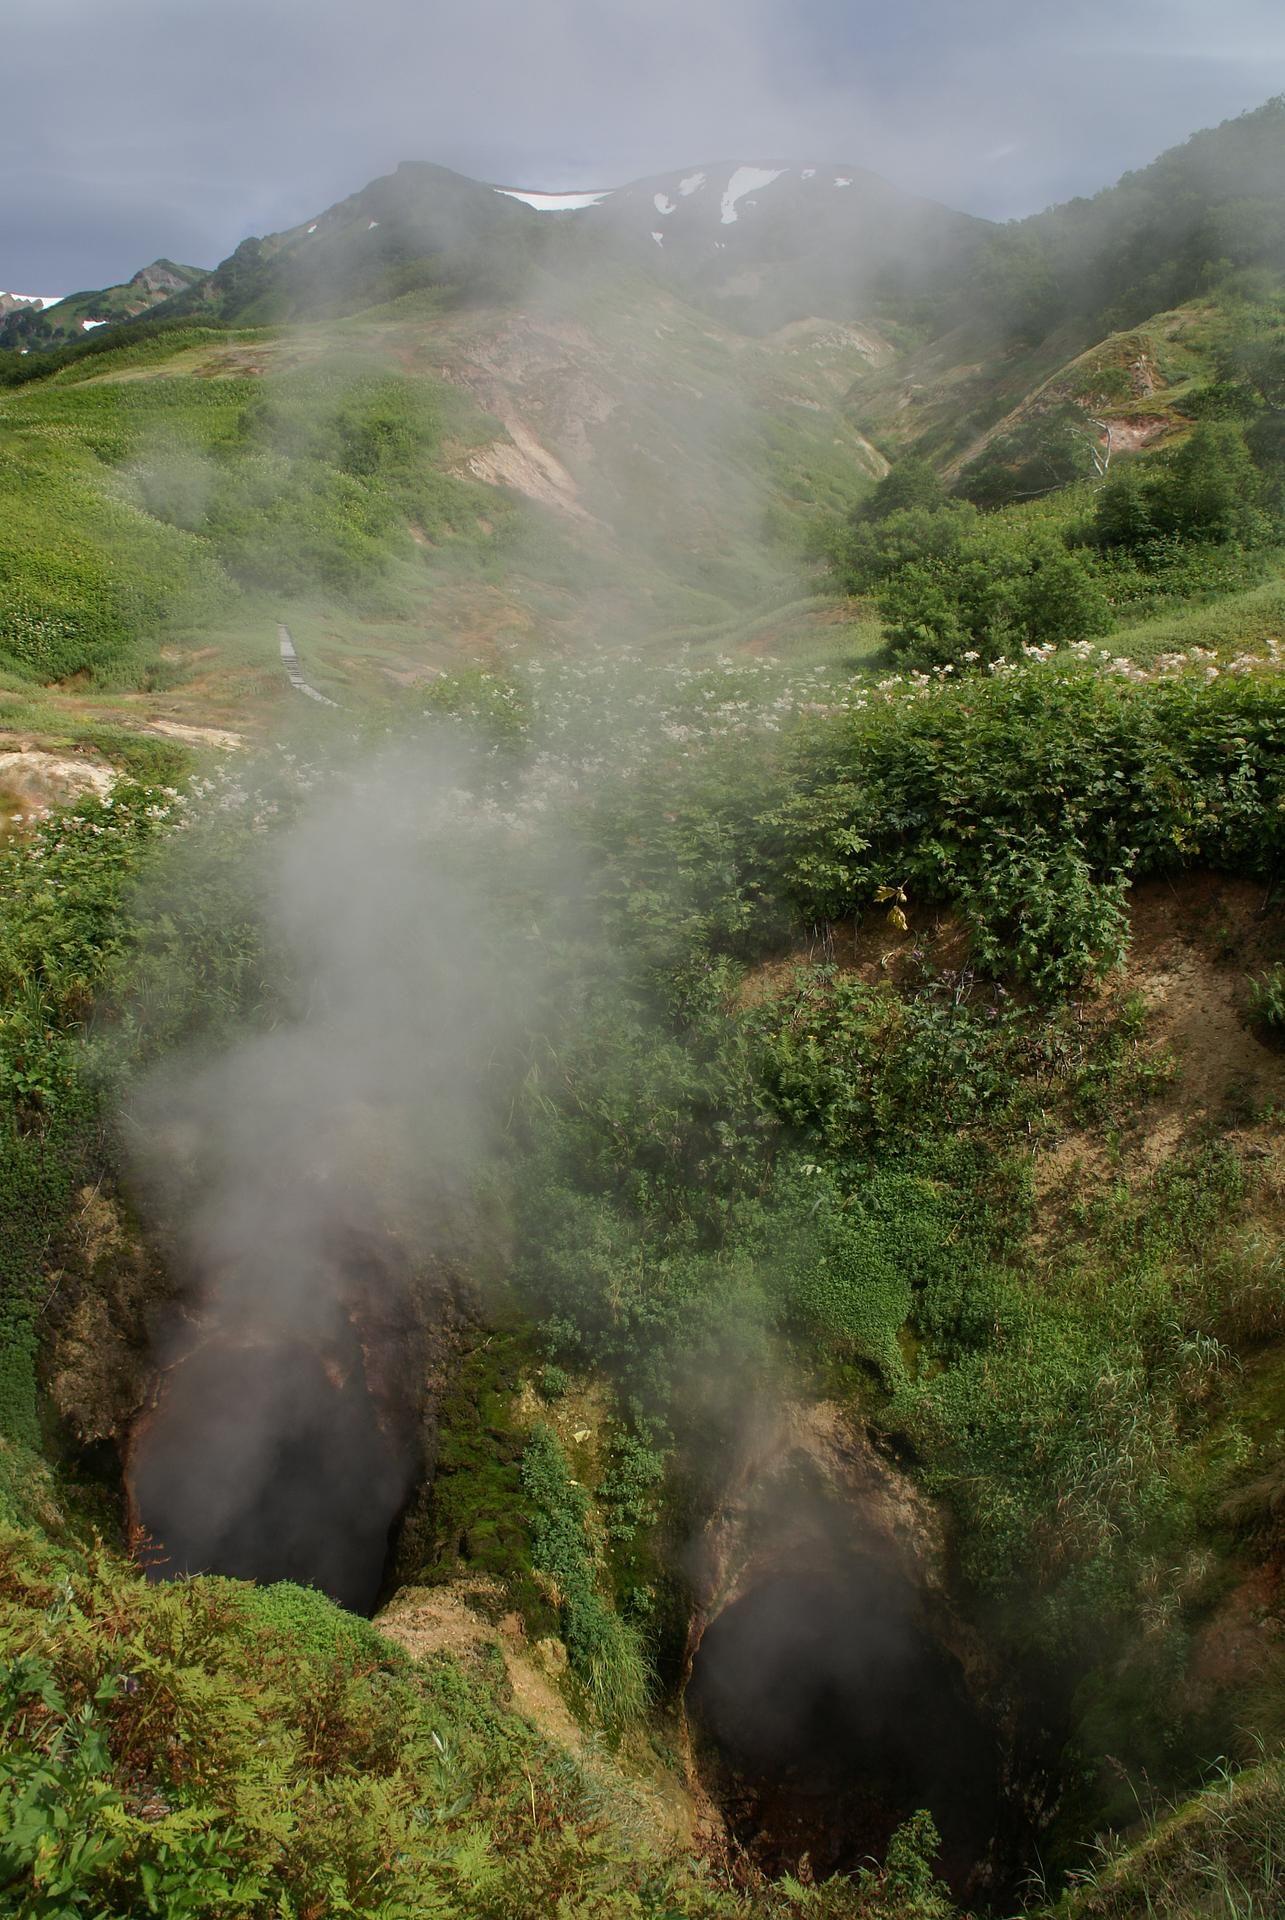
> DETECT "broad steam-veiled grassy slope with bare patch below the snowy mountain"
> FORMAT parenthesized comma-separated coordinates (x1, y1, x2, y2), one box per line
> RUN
(0, 288, 898, 730)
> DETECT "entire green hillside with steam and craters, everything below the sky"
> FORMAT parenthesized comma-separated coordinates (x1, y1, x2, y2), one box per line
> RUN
(0, 104, 1285, 1920)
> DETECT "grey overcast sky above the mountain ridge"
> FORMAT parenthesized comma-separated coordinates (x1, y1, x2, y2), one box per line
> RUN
(0, 0, 1285, 294)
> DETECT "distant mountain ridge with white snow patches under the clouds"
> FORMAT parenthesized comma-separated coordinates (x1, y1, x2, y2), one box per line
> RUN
(0, 161, 989, 349)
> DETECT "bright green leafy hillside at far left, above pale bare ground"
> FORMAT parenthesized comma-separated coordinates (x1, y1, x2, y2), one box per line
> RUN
(0, 345, 505, 685)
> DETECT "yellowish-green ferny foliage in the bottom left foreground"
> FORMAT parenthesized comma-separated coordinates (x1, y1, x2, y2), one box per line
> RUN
(0, 1528, 739, 1920)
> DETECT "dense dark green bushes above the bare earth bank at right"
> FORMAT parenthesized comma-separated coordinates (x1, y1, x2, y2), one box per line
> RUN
(756, 672, 1285, 960)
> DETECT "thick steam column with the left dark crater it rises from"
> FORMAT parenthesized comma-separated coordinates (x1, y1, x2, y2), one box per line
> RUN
(127, 755, 532, 1605)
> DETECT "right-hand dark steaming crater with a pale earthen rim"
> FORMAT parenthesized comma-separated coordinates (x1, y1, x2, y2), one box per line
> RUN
(684, 1398, 1051, 1903)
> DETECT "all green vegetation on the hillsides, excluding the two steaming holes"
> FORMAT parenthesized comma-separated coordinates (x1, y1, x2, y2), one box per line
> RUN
(0, 104, 1285, 1920)
